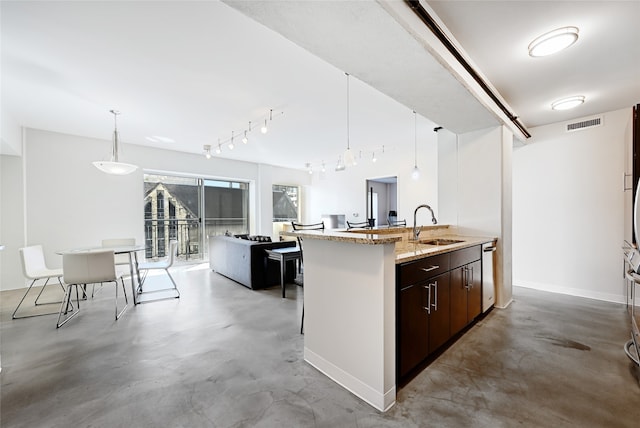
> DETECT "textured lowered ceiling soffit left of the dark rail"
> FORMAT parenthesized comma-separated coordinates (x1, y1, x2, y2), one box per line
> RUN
(224, 0, 500, 133)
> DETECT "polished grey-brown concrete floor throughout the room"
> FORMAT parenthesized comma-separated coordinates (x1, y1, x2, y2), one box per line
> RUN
(0, 265, 640, 428)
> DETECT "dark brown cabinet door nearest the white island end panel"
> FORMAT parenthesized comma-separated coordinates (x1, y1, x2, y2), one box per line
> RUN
(398, 284, 429, 377)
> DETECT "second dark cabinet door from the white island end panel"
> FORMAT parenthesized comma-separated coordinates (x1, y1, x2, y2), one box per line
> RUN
(428, 272, 451, 353)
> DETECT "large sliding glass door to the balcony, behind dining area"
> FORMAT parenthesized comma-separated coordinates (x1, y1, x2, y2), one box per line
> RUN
(144, 174, 249, 260)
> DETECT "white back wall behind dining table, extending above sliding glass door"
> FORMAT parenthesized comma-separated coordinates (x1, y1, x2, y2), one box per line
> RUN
(0, 129, 309, 290)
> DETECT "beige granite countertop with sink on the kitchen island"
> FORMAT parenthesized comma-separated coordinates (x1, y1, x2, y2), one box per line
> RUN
(280, 225, 497, 264)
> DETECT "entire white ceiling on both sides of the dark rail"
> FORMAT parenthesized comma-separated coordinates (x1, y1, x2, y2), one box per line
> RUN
(0, 1, 640, 168)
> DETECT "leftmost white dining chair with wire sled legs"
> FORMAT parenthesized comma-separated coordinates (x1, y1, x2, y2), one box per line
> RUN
(11, 245, 65, 319)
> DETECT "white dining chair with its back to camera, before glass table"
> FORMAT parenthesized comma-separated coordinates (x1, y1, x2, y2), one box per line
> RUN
(56, 250, 129, 328)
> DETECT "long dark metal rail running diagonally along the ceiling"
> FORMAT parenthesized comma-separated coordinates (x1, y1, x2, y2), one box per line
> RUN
(405, 0, 531, 138)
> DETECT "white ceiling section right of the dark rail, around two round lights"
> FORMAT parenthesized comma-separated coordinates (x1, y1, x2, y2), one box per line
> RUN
(429, 0, 640, 127)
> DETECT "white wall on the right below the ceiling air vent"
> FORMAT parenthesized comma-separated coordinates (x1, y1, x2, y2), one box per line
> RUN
(513, 108, 631, 302)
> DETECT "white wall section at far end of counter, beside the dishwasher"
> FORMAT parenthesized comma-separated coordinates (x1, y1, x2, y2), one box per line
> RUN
(438, 123, 513, 307)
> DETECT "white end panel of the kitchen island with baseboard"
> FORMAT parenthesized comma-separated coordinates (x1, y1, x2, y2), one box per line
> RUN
(304, 238, 396, 411)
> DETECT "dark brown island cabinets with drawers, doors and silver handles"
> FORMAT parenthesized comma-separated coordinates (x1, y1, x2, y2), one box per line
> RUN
(396, 245, 482, 378)
